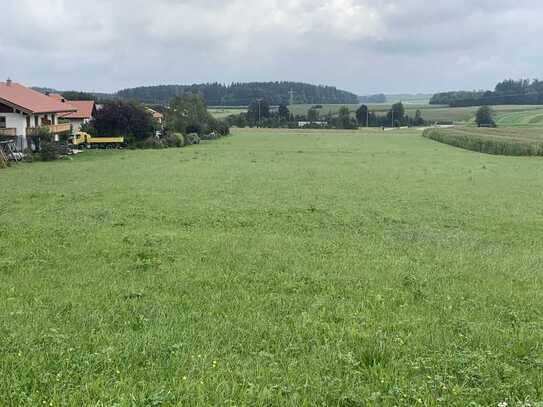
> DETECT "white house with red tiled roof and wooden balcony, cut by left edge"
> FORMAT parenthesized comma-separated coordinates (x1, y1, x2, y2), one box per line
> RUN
(0, 79, 78, 150)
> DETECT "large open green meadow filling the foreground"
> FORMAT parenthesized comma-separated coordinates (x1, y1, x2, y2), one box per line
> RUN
(0, 130, 543, 406)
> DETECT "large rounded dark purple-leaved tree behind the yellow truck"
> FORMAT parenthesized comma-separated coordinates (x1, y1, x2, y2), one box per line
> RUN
(91, 102, 156, 143)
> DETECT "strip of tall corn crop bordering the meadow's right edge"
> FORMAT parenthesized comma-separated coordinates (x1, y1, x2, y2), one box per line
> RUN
(423, 128, 543, 156)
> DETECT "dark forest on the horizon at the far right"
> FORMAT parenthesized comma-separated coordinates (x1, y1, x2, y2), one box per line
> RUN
(430, 79, 543, 107)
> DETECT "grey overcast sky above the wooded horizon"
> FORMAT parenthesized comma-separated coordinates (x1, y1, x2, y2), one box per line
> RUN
(0, 0, 543, 94)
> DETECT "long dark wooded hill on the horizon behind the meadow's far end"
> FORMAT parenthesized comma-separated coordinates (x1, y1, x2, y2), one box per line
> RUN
(116, 82, 358, 106)
